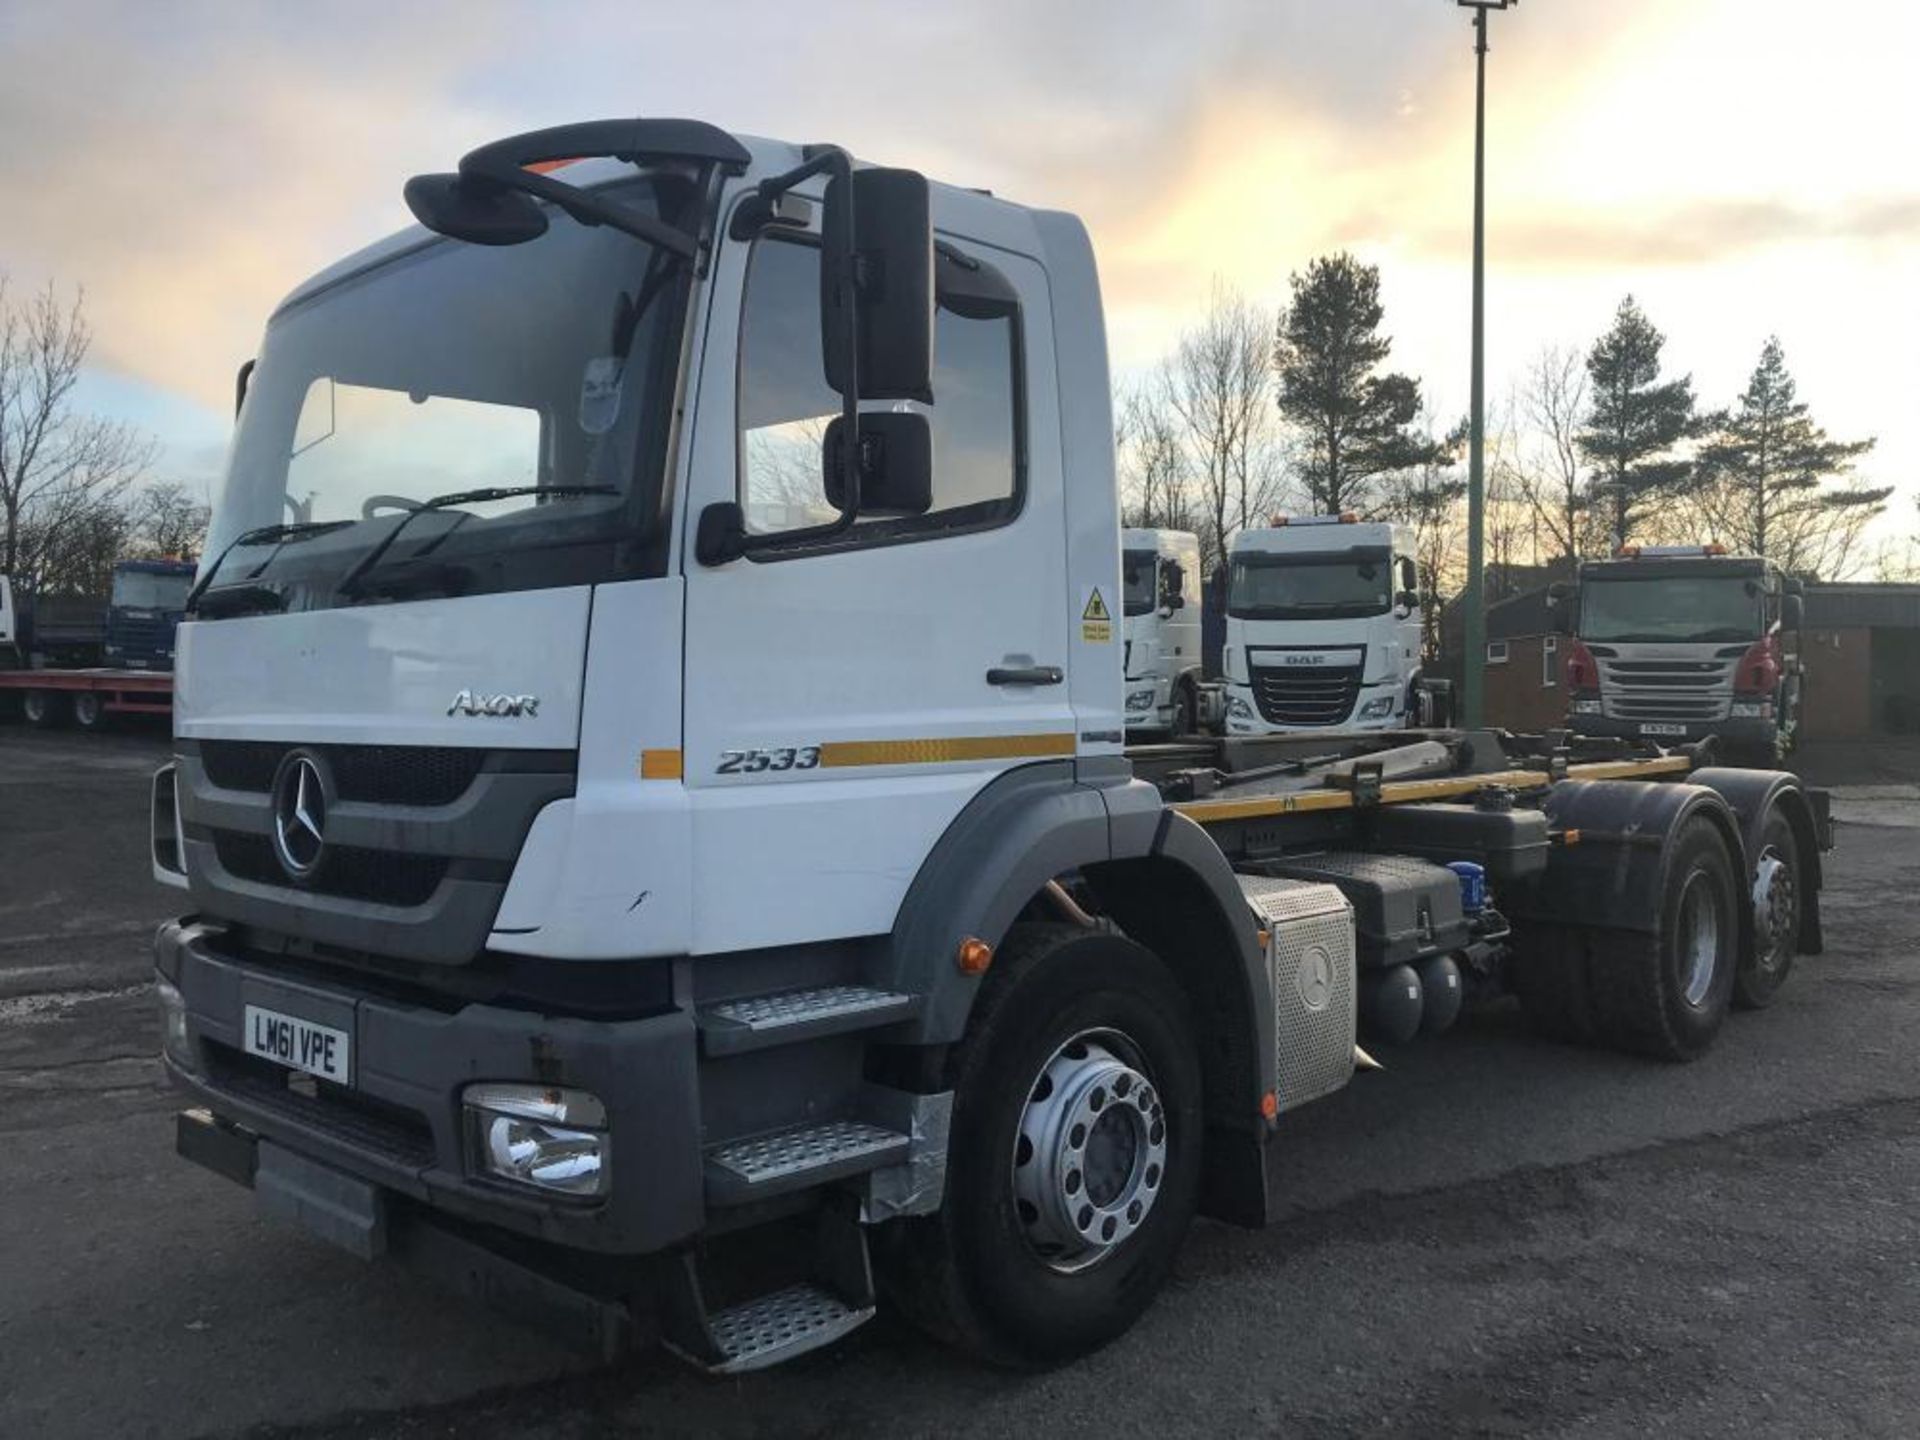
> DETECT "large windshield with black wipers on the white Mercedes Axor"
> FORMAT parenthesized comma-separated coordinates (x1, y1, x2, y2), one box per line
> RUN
(207, 180, 685, 609)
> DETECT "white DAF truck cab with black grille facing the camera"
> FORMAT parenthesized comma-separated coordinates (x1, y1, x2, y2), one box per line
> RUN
(1223, 515, 1421, 735)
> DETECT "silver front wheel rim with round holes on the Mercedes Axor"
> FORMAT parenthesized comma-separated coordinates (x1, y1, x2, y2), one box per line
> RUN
(1014, 1031, 1167, 1271)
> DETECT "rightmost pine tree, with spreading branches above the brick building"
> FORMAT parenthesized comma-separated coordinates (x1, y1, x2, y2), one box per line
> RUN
(1699, 338, 1893, 574)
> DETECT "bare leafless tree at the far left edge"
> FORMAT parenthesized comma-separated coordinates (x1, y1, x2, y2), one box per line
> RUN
(0, 275, 154, 586)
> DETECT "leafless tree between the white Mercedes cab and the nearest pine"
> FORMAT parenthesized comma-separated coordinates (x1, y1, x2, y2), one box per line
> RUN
(1164, 282, 1283, 572)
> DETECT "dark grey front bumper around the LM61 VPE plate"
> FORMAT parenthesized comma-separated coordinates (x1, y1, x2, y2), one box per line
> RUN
(154, 920, 705, 1254)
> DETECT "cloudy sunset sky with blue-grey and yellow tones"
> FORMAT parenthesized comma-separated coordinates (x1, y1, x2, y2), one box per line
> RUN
(0, 0, 1920, 552)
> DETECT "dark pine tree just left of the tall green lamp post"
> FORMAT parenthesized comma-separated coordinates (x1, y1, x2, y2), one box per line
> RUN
(1275, 253, 1432, 515)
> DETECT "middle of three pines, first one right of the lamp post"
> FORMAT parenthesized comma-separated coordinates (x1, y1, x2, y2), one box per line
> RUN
(1578, 296, 1697, 545)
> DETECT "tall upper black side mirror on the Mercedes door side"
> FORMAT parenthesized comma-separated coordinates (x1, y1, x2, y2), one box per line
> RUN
(820, 169, 933, 407)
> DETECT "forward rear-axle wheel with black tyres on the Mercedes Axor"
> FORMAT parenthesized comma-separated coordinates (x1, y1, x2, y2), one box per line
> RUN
(1513, 818, 1747, 1060)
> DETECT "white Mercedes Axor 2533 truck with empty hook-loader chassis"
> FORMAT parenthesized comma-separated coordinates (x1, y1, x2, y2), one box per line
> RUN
(154, 121, 1824, 1371)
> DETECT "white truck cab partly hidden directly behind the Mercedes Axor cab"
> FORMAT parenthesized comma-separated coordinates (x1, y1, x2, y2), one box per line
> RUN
(1119, 528, 1202, 737)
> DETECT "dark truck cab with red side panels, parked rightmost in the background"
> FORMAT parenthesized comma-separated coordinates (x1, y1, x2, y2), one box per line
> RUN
(1551, 545, 1803, 764)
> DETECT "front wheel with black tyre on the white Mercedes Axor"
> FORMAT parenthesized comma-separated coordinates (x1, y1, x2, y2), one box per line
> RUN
(874, 924, 1202, 1367)
